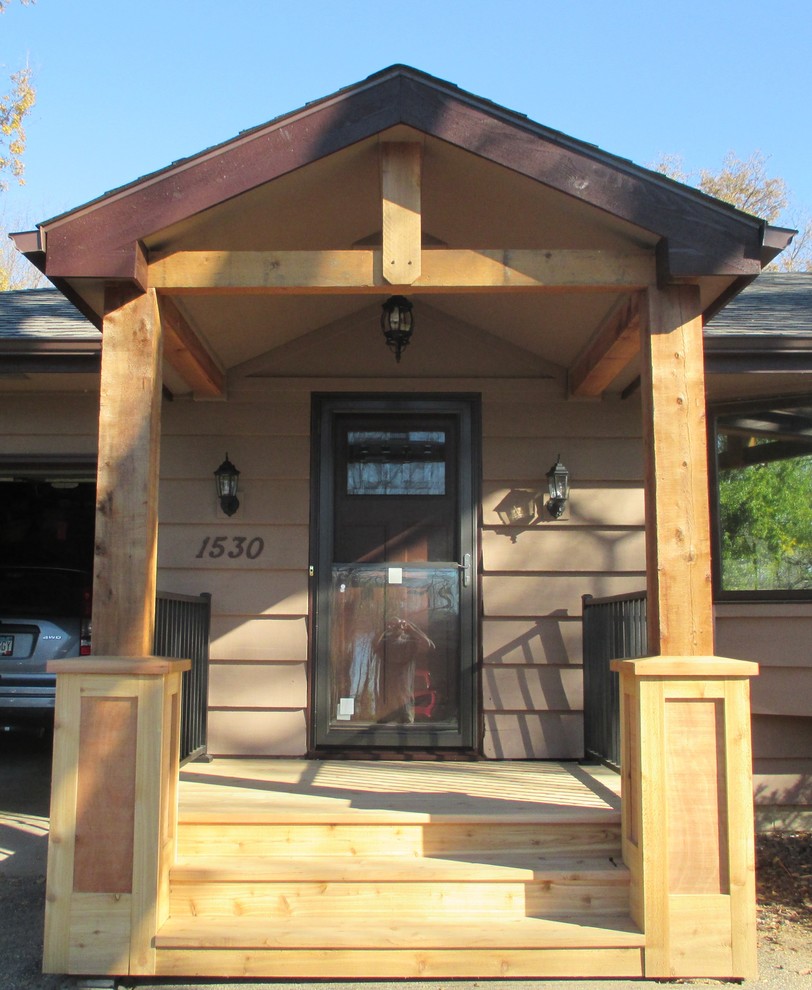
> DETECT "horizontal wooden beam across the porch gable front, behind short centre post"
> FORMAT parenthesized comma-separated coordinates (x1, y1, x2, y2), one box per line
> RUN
(149, 249, 655, 295)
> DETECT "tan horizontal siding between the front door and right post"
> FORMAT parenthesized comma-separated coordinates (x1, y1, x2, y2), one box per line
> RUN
(482, 388, 645, 759)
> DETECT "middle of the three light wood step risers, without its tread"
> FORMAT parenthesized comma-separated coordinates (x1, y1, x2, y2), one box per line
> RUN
(170, 871, 629, 922)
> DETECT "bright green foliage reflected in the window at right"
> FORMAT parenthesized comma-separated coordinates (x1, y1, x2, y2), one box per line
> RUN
(718, 436, 812, 591)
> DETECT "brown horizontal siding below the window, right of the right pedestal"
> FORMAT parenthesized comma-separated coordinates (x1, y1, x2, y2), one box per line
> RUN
(716, 602, 812, 829)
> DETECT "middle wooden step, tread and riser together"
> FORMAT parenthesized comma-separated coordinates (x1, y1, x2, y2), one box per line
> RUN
(169, 857, 629, 922)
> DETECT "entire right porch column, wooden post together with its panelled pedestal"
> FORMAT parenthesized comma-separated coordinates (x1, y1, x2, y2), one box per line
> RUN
(612, 285, 758, 979)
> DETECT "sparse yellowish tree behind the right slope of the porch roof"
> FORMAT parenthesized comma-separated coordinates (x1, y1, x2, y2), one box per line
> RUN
(651, 151, 812, 272)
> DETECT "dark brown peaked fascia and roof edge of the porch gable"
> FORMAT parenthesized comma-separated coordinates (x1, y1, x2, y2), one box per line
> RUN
(15, 65, 787, 287)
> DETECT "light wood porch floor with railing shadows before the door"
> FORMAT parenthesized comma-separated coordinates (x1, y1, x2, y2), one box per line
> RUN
(179, 758, 620, 824)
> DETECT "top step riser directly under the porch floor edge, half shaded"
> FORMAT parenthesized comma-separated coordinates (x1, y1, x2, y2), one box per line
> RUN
(178, 823, 620, 860)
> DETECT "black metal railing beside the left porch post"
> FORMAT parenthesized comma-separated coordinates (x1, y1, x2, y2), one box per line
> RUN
(153, 591, 211, 762)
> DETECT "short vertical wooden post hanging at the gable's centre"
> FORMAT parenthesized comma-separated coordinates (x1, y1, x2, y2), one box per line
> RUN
(381, 141, 423, 285)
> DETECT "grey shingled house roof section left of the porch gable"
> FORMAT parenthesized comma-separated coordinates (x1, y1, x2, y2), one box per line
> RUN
(0, 289, 101, 342)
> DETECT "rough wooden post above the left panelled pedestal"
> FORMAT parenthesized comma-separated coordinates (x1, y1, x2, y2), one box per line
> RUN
(93, 285, 161, 656)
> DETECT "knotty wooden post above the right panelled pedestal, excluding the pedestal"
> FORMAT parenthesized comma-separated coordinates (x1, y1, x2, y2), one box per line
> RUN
(641, 285, 713, 656)
